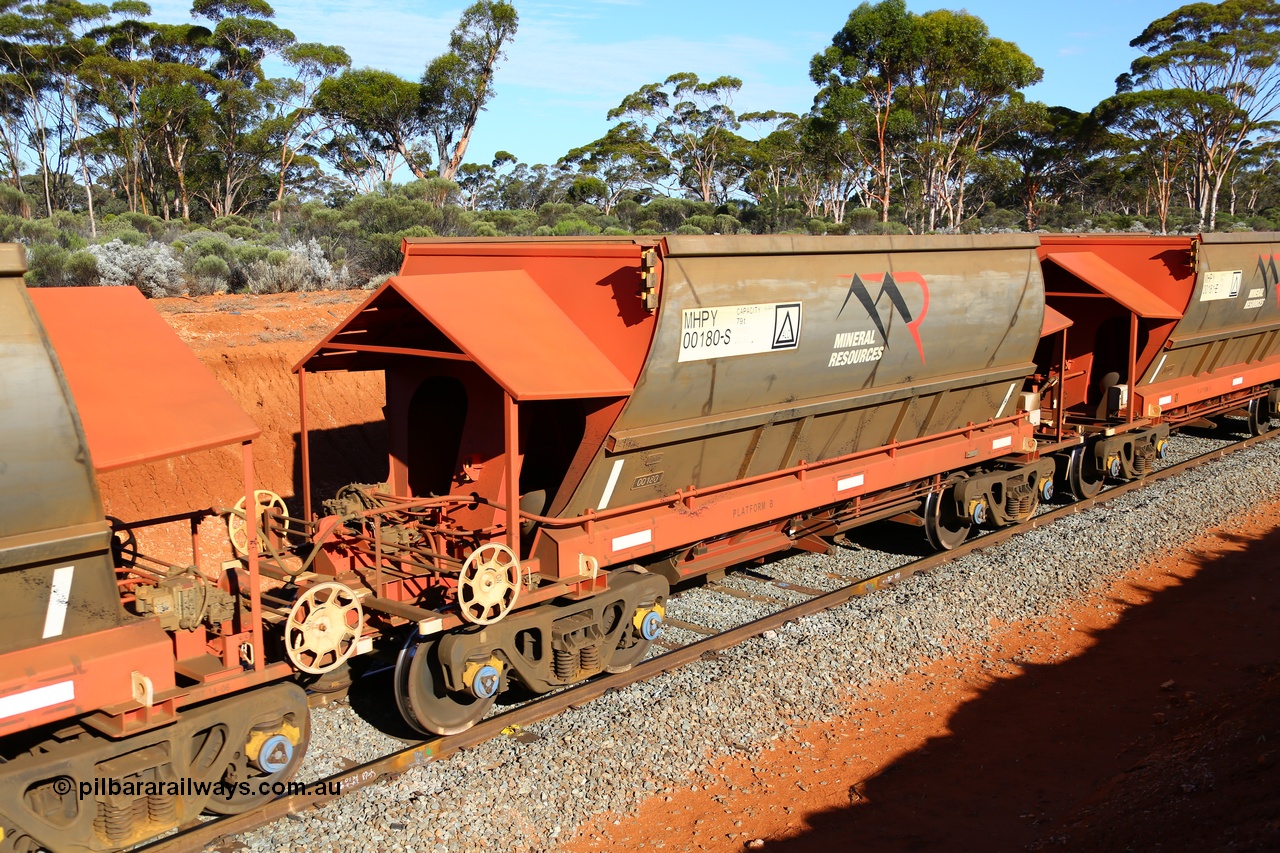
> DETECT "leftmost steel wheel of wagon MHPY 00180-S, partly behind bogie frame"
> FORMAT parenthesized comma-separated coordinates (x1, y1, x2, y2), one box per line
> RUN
(396, 631, 495, 735)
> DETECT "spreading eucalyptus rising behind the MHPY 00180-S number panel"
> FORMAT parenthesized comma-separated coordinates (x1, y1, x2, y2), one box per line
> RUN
(608, 72, 746, 202)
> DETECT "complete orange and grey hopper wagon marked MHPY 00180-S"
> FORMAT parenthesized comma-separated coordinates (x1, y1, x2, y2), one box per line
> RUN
(280, 236, 1055, 734)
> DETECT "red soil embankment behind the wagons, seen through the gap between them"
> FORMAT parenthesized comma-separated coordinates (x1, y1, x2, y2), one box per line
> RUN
(99, 291, 387, 569)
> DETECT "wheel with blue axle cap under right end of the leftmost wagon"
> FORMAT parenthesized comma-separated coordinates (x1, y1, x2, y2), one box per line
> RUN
(205, 684, 311, 815)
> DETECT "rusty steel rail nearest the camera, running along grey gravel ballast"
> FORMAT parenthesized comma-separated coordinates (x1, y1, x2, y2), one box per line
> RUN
(132, 432, 1276, 853)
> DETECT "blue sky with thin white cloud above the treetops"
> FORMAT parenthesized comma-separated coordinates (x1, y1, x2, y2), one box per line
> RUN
(151, 0, 1181, 164)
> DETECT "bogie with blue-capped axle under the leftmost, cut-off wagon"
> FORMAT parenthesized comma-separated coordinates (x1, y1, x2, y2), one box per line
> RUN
(0, 684, 310, 853)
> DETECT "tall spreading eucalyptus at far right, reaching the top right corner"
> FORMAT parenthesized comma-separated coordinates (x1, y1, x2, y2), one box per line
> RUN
(1116, 0, 1280, 229)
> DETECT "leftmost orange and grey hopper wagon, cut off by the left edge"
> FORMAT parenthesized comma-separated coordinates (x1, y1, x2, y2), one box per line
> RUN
(0, 246, 308, 853)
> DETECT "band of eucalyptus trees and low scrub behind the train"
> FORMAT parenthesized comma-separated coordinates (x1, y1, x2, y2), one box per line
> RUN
(0, 0, 1280, 294)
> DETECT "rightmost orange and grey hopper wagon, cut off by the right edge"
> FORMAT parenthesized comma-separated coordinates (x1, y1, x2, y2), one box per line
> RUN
(1032, 233, 1280, 497)
